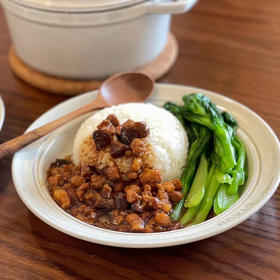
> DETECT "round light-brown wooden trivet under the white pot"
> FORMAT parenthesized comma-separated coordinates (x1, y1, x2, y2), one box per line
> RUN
(9, 33, 178, 95)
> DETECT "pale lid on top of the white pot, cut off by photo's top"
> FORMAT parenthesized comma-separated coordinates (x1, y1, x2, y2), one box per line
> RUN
(12, 0, 149, 12)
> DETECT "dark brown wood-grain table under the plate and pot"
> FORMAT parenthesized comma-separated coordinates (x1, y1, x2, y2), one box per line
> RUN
(0, 0, 280, 280)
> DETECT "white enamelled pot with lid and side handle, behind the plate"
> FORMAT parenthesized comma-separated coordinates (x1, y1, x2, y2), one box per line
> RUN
(2, 0, 196, 79)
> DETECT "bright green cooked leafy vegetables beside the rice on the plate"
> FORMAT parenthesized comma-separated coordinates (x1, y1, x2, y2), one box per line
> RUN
(164, 94, 246, 225)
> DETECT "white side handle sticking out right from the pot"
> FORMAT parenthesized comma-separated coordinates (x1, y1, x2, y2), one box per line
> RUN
(147, 0, 197, 14)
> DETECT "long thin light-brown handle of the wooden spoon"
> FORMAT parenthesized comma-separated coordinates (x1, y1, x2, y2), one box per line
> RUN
(0, 95, 108, 159)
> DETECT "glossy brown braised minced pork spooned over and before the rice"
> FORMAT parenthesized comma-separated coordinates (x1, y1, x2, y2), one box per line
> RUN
(47, 115, 183, 232)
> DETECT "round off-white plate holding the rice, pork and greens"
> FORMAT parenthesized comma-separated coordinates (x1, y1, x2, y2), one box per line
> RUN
(12, 84, 280, 248)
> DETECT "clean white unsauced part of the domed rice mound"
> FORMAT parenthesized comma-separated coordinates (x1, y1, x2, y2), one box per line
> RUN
(73, 103, 189, 181)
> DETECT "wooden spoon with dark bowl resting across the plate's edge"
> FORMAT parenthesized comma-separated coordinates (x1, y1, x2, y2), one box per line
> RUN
(0, 73, 154, 159)
